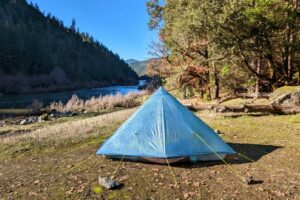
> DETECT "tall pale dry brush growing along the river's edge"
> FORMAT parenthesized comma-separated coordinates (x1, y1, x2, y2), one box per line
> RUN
(50, 92, 144, 112)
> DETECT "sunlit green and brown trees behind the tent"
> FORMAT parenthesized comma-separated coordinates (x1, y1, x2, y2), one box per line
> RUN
(147, 0, 300, 99)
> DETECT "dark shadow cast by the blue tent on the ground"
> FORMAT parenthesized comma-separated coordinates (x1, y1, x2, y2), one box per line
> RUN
(173, 143, 282, 168)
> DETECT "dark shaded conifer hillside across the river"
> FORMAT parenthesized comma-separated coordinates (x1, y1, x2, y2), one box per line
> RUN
(0, 0, 138, 93)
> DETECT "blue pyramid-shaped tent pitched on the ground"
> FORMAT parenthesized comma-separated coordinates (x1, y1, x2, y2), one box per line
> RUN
(97, 87, 236, 161)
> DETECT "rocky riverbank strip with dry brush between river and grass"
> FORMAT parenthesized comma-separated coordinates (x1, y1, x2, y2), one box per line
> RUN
(0, 91, 146, 127)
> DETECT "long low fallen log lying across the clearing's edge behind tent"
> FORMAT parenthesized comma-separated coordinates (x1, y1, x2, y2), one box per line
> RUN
(186, 104, 300, 115)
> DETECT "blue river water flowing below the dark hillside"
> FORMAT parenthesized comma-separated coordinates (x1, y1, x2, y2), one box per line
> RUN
(0, 80, 146, 109)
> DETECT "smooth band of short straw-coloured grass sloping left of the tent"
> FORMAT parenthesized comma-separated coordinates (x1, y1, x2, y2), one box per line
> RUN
(0, 108, 136, 144)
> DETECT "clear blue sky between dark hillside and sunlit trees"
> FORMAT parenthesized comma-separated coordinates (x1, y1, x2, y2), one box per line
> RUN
(29, 0, 158, 60)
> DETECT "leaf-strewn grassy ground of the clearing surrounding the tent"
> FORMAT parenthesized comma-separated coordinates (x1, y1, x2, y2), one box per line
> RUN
(0, 105, 300, 199)
